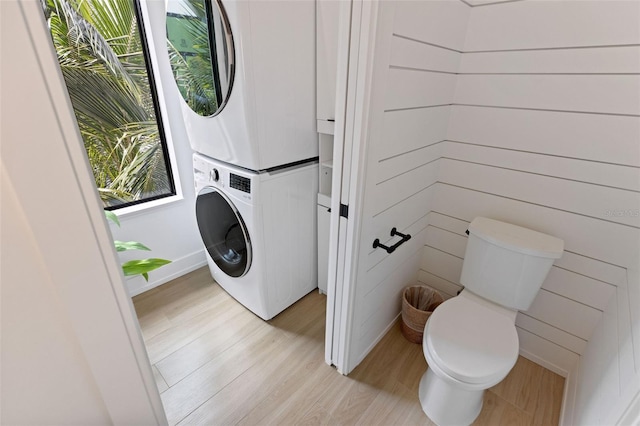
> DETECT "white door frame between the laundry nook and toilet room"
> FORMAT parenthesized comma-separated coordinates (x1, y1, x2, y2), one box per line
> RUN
(325, 0, 379, 375)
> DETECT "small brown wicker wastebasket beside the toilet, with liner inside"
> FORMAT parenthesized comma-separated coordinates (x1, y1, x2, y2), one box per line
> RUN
(401, 285, 444, 343)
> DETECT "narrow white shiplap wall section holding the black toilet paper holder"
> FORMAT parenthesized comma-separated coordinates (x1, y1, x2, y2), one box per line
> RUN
(347, 1, 469, 370)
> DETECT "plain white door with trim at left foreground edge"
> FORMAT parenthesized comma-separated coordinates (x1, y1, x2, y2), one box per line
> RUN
(0, 0, 167, 424)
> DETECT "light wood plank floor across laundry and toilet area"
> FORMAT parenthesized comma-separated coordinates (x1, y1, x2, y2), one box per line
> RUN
(134, 268, 564, 425)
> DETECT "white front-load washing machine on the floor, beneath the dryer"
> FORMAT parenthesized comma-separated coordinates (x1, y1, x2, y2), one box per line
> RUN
(193, 154, 318, 320)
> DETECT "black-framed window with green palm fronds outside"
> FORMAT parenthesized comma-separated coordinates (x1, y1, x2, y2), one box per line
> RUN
(43, 0, 176, 210)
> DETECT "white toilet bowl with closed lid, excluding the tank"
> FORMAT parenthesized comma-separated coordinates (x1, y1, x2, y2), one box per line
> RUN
(419, 291, 519, 426)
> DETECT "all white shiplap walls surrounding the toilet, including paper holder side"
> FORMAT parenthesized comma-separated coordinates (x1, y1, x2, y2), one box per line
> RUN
(352, 0, 640, 423)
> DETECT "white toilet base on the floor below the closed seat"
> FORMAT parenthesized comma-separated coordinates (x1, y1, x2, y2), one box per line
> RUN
(419, 367, 484, 426)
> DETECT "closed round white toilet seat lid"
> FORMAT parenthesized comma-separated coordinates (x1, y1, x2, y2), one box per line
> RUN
(423, 296, 519, 387)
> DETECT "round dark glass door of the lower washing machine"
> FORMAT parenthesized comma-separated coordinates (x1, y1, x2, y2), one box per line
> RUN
(196, 187, 252, 277)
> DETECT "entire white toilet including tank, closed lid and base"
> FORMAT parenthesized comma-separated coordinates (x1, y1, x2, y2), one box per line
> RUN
(419, 217, 564, 426)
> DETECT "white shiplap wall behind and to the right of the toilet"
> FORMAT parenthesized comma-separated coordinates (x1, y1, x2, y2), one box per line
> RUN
(412, 1, 640, 424)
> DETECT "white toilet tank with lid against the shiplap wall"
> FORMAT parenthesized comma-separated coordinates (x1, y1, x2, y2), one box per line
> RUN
(460, 217, 564, 310)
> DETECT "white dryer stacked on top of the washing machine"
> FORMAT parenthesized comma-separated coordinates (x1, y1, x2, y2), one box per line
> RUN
(167, 0, 318, 170)
